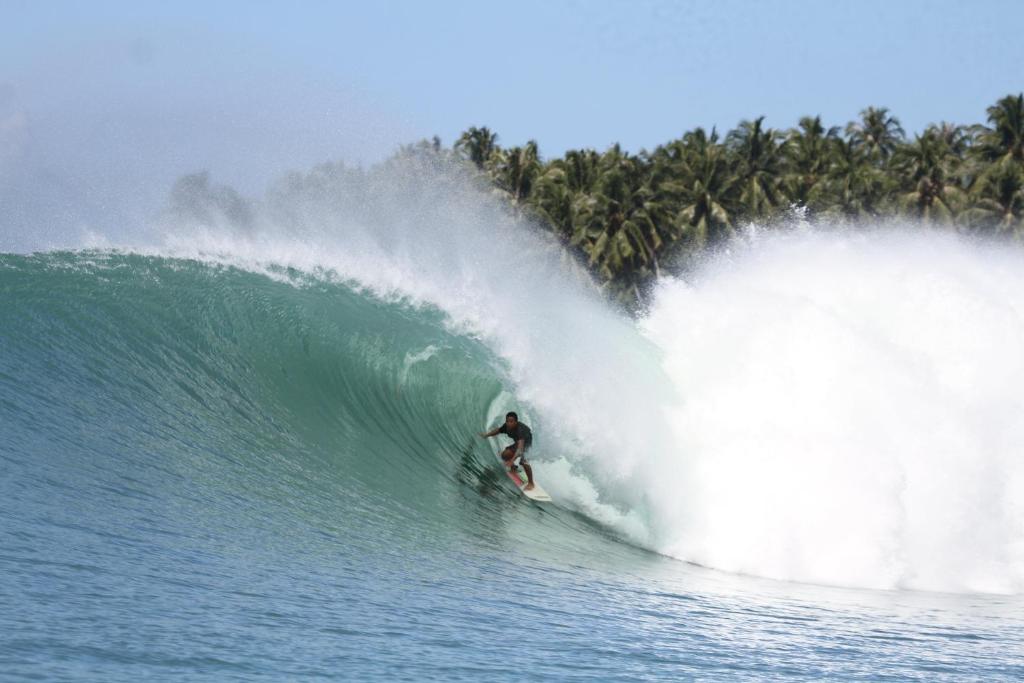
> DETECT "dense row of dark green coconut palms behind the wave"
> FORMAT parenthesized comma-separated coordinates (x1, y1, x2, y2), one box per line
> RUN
(430, 94, 1024, 307)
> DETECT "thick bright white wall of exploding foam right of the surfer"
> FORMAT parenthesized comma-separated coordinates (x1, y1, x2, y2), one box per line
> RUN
(642, 228, 1024, 592)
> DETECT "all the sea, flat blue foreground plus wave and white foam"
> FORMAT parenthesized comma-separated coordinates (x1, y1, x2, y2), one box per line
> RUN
(6, 187, 1024, 681)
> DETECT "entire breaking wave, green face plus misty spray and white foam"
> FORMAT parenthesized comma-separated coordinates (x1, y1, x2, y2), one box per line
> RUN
(6, 154, 1024, 593)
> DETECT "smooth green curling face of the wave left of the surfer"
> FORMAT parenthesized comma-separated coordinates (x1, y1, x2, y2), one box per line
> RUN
(0, 252, 512, 528)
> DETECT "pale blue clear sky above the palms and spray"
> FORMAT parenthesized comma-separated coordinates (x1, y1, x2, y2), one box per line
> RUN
(0, 0, 1024, 200)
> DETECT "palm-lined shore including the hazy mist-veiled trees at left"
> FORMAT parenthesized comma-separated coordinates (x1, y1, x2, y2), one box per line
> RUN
(168, 93, 1024, 313)
